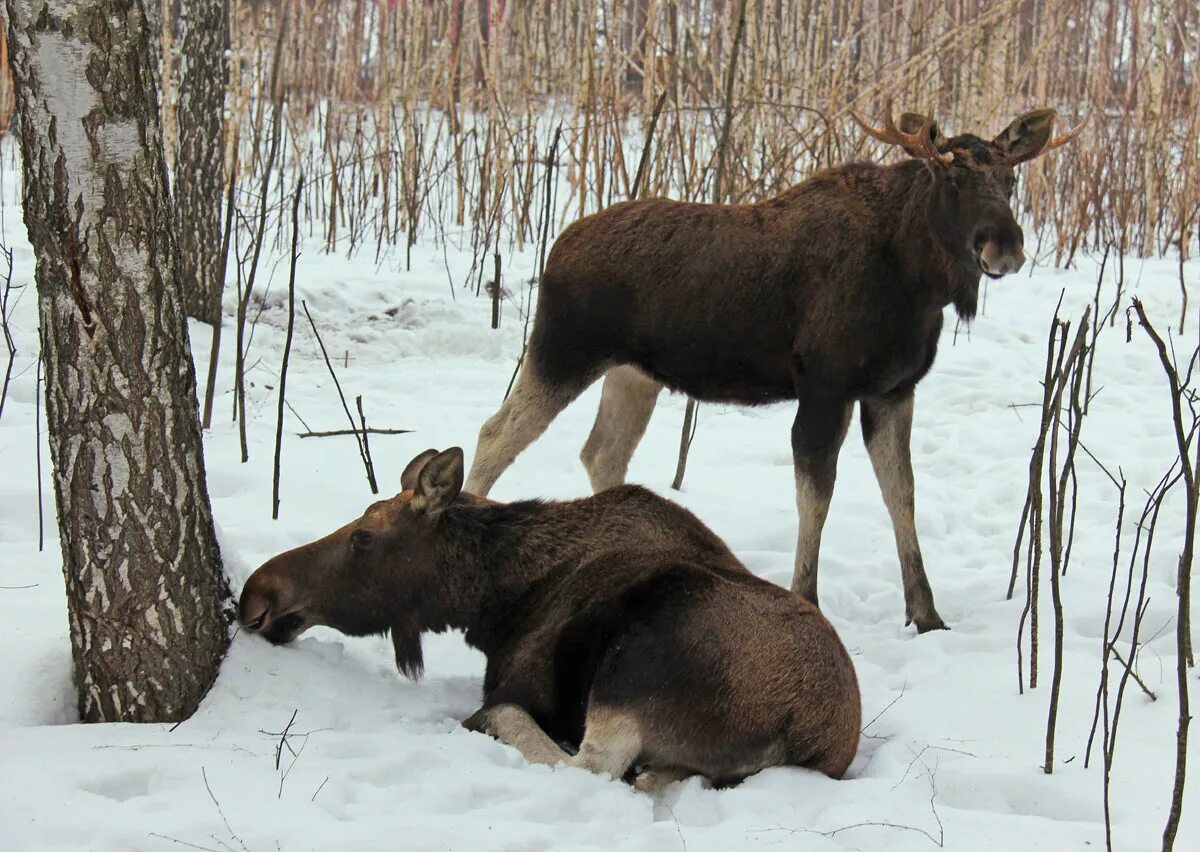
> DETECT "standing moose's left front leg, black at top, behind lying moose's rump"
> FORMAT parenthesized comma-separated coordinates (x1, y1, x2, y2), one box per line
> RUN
(792, 391, 853, 604)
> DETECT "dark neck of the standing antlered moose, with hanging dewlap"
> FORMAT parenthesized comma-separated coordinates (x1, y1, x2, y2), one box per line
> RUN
(883, 160, 980, 320)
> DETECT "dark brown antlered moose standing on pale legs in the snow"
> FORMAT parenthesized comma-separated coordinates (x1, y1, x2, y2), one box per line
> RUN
(466, 101, 1082, 632)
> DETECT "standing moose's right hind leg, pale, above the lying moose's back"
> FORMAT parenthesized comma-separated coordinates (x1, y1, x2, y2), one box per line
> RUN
(580, 365, 662, 492)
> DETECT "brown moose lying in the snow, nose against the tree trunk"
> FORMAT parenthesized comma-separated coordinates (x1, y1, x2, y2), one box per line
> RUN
(240, 448, 862, 790)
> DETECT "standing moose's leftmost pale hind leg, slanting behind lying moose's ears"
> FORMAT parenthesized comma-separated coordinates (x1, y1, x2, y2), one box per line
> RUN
(463, 361, 593, 497)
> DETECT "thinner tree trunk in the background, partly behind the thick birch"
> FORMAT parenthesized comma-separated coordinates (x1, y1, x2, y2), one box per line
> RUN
(175, 0, 226, 323)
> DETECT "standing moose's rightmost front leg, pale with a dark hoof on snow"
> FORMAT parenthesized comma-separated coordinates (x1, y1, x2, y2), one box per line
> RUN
(862, 391, 946, 632)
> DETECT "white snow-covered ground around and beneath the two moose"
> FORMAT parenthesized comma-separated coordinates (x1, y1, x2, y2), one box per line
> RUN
(0, 163, 1200, 852)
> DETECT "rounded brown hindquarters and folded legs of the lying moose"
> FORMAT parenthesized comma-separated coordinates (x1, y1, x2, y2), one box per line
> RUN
(464, 547, 860, 790)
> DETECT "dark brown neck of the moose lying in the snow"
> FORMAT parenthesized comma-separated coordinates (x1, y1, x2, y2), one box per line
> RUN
(421, 500, 604, 654)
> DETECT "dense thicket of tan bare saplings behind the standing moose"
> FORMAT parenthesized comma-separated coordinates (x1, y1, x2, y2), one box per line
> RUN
(154, 0, 1200, 274)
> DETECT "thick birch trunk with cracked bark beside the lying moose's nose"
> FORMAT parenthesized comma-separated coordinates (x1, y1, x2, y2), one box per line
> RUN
(6, 0, 229, 721)
